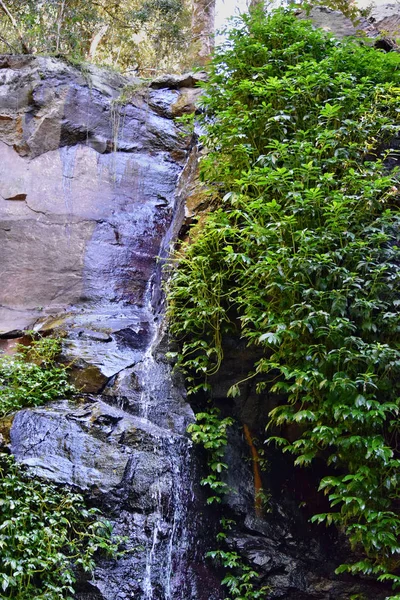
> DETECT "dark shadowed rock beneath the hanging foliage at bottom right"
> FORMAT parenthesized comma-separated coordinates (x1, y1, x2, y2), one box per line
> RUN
(217, 426, 390, 600)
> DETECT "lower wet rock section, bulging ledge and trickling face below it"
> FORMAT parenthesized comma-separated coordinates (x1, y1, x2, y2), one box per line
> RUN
(11, 399, 203, 599)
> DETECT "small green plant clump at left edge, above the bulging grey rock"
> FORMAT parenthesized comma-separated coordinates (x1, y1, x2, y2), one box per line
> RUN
(0, 338, 74, 417)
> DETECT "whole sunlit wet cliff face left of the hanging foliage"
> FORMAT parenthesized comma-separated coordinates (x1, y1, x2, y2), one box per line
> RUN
(0, 56, 218, 600)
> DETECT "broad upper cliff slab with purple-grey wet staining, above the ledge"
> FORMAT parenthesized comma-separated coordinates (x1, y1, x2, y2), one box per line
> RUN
(0, 56, 187, 334)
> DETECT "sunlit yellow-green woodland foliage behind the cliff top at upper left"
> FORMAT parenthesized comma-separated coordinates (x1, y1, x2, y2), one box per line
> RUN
(0, 0, 190, 75)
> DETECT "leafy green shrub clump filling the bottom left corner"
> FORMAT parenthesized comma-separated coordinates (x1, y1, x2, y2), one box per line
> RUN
(0, 454, 117, 600)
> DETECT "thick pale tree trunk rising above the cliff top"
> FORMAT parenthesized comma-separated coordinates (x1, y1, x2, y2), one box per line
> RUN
(192, 0, 215, 65)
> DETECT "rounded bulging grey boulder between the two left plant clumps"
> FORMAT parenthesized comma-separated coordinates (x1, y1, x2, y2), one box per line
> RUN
(11, 401, 178, 494)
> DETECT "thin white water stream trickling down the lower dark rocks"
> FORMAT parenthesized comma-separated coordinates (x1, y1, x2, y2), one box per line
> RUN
(135, 280, 194, 600)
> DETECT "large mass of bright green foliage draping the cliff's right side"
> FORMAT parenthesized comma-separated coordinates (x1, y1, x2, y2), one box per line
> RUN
(169, 10, 400, 598)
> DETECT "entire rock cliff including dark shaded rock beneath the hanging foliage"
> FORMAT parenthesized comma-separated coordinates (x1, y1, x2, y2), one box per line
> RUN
(0, 9, 398, 600)
